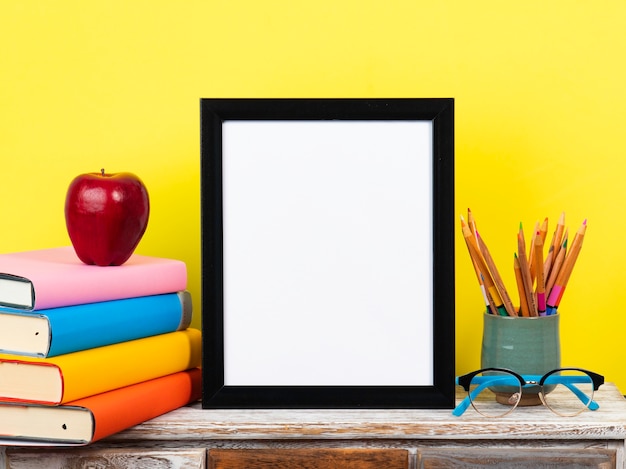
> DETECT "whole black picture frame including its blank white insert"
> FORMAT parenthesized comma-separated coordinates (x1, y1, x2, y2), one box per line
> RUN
(200, 98, 455, 409)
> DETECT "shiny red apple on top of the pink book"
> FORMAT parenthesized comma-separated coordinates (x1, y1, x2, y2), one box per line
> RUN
(65, 169, 150, 266)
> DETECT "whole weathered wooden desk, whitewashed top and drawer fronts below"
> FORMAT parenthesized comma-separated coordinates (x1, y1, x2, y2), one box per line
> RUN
(0, 383, 626, 469)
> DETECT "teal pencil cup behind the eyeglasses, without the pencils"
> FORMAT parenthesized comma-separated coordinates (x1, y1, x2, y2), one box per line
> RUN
(481, 312, 561, 406)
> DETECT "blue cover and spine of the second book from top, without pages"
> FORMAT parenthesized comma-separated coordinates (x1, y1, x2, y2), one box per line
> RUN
(46, 291, 192, 357)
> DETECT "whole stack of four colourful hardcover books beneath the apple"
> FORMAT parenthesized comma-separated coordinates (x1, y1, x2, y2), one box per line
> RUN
(0, 246, 201, 445)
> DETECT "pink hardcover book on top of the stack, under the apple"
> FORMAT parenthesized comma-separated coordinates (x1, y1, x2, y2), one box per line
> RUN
(0, 246, 187, 310)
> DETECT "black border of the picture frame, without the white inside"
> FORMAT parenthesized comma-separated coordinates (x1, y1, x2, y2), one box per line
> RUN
(200, 98, 455, 409)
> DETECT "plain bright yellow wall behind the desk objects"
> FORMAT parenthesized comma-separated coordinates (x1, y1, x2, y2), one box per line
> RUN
(0, 0, 626, 392)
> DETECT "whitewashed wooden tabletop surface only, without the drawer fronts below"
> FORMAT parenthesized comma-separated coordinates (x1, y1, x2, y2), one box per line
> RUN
(107, 383, 626, 441)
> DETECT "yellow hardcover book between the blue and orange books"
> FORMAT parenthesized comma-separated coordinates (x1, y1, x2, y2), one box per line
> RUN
(0, 328, 202, 405)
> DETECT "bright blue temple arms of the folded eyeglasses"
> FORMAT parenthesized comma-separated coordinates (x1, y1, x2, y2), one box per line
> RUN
(452, 375, 600, 417)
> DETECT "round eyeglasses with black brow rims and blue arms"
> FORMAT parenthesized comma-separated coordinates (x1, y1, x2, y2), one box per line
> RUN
(452, 368, 604, 417)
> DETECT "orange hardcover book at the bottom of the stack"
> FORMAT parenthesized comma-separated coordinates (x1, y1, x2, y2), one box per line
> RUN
(0, 368, 202, 446)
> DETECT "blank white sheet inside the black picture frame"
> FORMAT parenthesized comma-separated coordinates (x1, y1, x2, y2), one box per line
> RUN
(222, 120, 433, 386)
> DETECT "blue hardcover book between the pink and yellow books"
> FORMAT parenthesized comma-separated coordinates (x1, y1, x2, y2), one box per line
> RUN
(0, 290, 192, 357)
